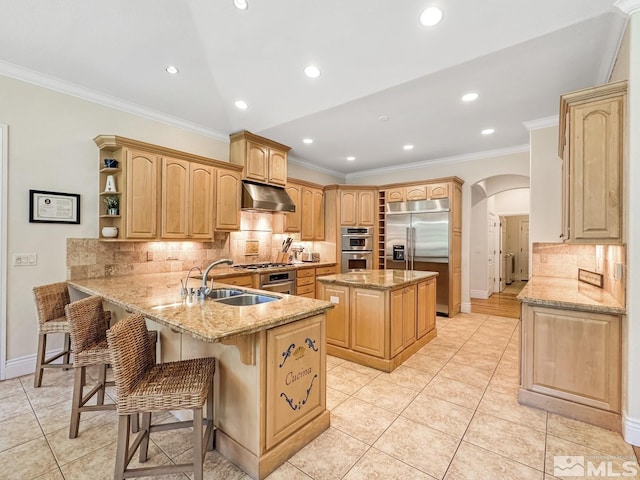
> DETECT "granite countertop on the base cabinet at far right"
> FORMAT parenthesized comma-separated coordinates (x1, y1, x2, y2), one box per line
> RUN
(518, 277, 625, 314)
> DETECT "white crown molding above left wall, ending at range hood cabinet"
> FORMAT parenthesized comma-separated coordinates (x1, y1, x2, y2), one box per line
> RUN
(0, 61, 229, 143)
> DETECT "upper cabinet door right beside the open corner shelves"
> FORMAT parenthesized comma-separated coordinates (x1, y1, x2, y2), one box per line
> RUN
(126, 150, 160, 238)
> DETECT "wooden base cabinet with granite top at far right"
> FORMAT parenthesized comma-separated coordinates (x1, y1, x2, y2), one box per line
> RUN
(518, 277, 625, 432)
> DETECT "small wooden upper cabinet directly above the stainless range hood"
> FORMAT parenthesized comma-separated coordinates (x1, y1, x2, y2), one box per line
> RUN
(229, 130, 290, 187)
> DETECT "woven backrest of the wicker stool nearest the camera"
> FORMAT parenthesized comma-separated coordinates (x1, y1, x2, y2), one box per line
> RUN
(107, 314, 154, 400)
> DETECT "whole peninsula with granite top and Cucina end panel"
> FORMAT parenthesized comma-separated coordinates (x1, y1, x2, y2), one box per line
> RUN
(68, 273, 332, 479)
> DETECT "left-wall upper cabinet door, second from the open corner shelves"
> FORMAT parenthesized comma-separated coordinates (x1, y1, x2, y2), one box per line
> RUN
(161, 157, 189, 238)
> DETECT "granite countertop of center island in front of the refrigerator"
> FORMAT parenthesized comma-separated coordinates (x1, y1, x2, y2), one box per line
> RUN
(317, 270, 438, 290)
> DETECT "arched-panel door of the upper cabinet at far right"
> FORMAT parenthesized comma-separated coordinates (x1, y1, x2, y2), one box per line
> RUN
(569, 97, 624, 240)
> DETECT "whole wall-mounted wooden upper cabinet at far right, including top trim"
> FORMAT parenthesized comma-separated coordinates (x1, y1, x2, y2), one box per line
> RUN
(559, 81, 627, 243)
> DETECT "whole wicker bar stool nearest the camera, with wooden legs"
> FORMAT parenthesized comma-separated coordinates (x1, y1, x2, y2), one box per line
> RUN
(107, 314, 216, 480)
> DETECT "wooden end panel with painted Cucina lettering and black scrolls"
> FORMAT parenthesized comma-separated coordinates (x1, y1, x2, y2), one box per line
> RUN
(265, 316, 326, 450)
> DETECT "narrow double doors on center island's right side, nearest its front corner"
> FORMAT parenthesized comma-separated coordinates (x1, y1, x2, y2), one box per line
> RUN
(390, 285, 417, 356)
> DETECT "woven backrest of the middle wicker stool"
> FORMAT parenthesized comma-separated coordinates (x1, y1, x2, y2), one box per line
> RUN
(65, 295, 107, 352)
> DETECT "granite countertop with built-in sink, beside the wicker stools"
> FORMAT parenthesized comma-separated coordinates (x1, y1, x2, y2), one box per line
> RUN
(67, 273, 333, 342)
